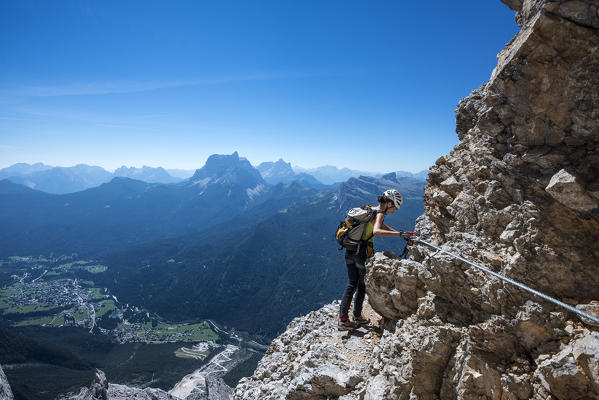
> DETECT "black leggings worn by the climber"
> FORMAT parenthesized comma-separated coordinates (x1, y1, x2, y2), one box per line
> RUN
(339, 246, 366, 318)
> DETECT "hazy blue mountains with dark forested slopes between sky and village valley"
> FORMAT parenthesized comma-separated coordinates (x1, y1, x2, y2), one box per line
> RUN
(0, 153, 425, 337)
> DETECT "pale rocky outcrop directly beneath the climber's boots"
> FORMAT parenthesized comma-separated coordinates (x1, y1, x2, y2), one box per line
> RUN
(233, 302, 378, 400)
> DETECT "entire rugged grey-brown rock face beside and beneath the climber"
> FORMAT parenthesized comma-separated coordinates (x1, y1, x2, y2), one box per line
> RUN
(234, 0, 599, 400)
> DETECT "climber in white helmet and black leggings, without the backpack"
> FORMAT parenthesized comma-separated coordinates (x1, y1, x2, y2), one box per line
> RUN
(337, 189, 414, 330)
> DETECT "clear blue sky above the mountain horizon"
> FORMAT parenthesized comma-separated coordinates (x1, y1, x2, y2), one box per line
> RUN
(0, 0, 517, 172)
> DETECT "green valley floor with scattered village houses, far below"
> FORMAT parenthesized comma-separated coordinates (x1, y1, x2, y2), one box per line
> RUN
(0, 255, 219, 348)
